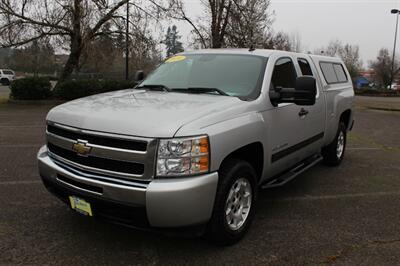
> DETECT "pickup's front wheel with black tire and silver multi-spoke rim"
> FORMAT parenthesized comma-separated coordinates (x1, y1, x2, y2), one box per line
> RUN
(206, 159, 258, 246)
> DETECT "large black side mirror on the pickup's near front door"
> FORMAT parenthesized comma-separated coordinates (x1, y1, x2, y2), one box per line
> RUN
(269, 76, 317, 106)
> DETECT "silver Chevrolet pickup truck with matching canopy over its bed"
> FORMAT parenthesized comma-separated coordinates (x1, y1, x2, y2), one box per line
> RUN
(38, 49, 354, 244)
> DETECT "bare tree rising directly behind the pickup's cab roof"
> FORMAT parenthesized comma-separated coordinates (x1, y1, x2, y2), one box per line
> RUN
(170, 0, 272, 48)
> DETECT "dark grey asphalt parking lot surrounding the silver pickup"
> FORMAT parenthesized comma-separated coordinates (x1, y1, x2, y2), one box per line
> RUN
(0, 98, 400, 265)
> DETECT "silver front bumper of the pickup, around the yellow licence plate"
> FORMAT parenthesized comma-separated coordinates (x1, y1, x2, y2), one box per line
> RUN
(37, 146, 218, 228)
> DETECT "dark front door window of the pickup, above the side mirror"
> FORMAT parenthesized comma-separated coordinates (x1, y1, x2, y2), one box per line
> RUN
(271, 58, 297, 88)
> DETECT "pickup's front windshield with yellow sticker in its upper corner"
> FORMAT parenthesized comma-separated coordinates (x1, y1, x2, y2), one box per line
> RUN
(140, 54, 267, 98)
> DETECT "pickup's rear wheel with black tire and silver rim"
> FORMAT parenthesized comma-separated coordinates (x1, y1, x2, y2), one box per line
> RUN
(322, 121, 347, 166)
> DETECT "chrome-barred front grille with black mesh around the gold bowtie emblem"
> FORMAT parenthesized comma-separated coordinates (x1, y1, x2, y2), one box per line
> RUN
(46, 123, 157, 181)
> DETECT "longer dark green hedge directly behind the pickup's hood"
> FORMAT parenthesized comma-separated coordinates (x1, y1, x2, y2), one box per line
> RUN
(54, 80, 135, 101)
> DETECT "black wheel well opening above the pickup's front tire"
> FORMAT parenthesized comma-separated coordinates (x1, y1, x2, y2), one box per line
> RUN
(221, 142, 264, 182)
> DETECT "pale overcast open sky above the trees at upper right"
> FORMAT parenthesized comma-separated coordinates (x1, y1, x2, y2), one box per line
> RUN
(175, 0, 400, 65)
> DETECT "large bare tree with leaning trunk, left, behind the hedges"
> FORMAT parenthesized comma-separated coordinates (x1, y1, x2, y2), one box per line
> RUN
(0, 0, 164, 80)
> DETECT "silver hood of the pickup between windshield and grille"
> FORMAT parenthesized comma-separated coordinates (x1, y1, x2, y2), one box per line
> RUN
(47, 89, 242, 138)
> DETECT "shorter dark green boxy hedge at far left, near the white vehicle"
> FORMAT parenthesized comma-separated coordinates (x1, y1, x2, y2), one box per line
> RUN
(10, 77, 52, 100)
